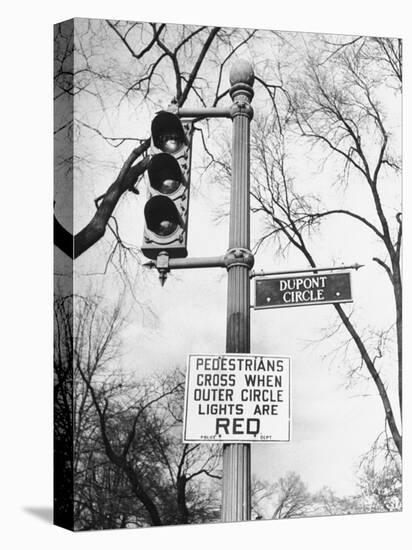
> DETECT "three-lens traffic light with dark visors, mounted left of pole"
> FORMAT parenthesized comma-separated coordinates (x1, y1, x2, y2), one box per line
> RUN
(142, 111, 193, 260)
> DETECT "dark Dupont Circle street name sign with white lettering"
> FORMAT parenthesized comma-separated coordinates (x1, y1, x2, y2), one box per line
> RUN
(254, 272, 353, 309)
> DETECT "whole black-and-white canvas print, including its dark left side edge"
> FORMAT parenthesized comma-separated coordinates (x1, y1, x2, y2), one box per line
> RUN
(54, 18, 402, 530)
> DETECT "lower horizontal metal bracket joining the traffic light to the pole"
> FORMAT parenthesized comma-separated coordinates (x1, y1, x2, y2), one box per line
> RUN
(143, 248, 255, 286)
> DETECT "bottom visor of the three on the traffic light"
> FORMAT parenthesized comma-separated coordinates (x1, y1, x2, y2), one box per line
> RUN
(144, 195, 183, 237)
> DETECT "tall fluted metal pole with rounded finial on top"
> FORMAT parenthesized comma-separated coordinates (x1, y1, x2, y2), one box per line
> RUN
(222, 60, 254, 522)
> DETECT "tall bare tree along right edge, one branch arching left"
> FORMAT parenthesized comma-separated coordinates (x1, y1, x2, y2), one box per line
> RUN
(293, 39, 402, 422)
